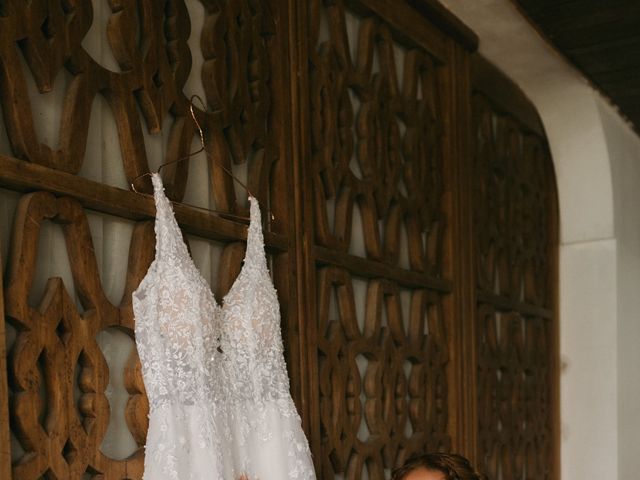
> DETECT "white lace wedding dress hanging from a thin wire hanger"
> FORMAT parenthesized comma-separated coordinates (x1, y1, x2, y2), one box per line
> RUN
(133, 174, 315, 480)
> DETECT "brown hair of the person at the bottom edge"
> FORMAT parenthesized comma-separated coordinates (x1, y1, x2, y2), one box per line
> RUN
(391, 453, 487, 480)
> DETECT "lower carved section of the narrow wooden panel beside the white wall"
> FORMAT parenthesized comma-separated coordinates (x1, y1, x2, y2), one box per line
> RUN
(478, 304, 553, 479)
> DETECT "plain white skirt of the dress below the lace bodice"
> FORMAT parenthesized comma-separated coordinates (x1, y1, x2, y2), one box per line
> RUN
(143, 399, 315, 480)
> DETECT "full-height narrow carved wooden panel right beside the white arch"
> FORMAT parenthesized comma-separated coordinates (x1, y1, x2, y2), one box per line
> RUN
(473, 93, 557, 480)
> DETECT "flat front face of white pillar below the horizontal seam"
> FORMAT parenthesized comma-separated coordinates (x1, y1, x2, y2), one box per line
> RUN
(560, 239, 622, 480)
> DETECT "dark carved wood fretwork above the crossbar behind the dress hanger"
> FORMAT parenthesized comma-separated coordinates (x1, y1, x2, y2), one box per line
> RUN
(0, 0, 275, 211)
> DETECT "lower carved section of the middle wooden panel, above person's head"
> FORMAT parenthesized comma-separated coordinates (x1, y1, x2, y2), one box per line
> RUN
(318, 267, 451, 479)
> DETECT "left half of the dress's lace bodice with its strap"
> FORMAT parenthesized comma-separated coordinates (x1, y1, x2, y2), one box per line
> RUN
(133, 175, 220, 411)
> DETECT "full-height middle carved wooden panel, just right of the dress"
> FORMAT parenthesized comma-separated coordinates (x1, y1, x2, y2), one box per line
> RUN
(305, 0, 452, 479)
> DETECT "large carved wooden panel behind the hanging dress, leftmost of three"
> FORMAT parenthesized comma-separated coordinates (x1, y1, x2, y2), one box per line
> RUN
(0, 0, 288, 480)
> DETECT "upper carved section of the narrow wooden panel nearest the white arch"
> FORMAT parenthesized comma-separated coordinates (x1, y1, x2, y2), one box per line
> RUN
(473, 95, 552, 307)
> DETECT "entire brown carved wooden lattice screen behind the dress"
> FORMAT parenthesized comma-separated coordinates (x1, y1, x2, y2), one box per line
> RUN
(0, 0, 557, 480)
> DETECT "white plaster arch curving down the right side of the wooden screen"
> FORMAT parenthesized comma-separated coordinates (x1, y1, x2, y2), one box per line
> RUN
(441, 0, 640, 480)
